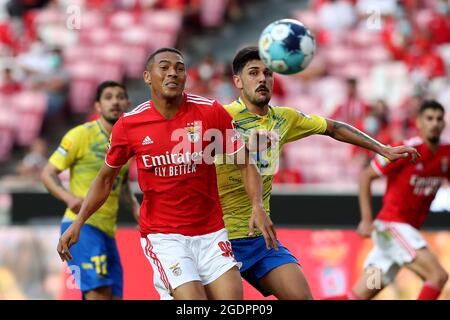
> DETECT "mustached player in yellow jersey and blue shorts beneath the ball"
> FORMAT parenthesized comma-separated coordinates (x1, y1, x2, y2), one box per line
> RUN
(216, 47, 418, 299)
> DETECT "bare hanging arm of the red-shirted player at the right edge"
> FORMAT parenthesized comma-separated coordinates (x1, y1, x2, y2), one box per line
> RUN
(357, 166, 378, 238)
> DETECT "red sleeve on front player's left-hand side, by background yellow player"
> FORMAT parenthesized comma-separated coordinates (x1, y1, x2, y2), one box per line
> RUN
(105, 116, 133, 168)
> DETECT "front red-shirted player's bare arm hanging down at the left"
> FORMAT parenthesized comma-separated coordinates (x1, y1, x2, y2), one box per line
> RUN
(57, 164, 120, 261)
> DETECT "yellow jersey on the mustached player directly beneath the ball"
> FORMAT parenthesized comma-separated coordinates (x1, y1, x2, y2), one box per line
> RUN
(216, 99, 327, 239)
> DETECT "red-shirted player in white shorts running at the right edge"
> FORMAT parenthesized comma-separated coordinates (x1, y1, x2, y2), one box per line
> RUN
(329, 100, 450, 300)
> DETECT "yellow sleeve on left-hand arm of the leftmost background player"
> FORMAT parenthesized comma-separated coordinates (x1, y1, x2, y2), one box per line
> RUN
(49, 126, 86, 171)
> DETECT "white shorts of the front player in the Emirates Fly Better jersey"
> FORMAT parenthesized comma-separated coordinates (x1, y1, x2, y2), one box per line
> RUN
(141, 229, 240, 300)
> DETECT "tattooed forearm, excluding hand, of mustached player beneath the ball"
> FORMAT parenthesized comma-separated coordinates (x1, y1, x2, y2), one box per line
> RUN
(325, 119, 386, 154)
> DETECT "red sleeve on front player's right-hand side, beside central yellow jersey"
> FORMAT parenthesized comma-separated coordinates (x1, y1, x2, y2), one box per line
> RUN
(213, 101, 245, 155)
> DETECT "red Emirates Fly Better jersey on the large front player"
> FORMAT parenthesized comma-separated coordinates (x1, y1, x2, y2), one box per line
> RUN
(105, 94, 244, 236)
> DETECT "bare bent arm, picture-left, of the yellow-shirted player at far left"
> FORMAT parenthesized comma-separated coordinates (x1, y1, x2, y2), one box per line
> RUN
(41, 162, 83, 213)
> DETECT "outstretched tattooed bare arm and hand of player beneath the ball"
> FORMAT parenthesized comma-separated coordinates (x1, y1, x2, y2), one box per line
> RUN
(324, 119, 420, 162)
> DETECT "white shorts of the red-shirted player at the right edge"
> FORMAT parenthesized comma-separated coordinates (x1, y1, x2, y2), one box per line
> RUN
(364, 220, 427, 285)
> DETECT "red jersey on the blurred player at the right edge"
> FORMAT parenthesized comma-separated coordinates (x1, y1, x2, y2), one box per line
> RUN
(371, 137, 450, 229)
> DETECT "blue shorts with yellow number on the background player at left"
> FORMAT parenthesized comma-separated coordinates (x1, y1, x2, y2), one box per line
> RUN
(61, 222, 123, 297)
